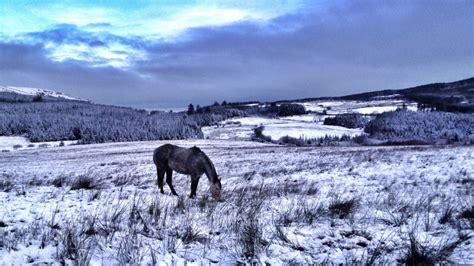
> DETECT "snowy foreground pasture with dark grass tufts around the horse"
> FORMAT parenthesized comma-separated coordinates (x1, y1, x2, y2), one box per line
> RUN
(0, 140, 474, 265)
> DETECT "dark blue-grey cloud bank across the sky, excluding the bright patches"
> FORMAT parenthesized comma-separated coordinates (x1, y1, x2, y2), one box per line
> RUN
(0, 1, 474, 107)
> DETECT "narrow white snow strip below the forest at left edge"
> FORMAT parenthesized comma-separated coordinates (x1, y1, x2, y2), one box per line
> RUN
(0, 136, 77, 152)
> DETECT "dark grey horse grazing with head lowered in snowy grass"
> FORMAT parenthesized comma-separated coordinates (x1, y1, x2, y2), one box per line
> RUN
(153, 144, 222, 200)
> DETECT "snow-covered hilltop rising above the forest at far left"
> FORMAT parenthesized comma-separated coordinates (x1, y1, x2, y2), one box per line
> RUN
(0, 86, 85, 102)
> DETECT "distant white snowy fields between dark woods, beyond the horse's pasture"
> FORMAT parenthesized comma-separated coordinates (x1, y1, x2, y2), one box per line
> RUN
(202, 100, 417, 140)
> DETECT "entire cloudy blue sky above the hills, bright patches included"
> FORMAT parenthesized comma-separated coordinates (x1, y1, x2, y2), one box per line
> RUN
(0, 0, 474, 109)
